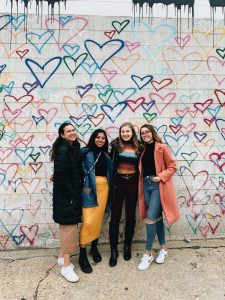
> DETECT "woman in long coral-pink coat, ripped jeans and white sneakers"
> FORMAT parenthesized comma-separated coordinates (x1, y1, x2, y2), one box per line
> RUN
(138, 124, 179, 271)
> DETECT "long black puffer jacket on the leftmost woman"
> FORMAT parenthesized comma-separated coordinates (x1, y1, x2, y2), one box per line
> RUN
(53, 140, 82, 225)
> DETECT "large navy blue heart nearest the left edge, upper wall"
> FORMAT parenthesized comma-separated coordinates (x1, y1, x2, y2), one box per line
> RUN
(25, 56, 62, 88)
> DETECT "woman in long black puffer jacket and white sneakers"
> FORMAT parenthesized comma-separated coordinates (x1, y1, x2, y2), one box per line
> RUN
(51, 123, 82, 282)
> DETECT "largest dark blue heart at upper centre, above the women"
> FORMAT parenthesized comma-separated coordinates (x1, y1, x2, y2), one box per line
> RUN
(84, 39, 124, 69)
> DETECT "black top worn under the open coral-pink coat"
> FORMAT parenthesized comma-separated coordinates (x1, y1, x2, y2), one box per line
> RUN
(141, 142, 156, 177)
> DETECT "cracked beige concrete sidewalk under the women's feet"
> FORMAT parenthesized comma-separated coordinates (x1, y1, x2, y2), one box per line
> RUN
(0, 239, 225, 300)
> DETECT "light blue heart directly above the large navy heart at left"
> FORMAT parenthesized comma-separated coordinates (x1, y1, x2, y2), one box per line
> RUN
(26, 30, 54, 54)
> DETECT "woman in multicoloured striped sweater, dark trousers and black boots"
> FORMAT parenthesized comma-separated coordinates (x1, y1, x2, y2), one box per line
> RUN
(109, 122, 140, 267)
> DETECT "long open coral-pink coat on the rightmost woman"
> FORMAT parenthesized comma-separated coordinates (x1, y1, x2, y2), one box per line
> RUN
(138, 142, 180, 225)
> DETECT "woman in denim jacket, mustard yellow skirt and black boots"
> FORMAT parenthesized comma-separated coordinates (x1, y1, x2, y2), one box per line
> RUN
(79, 129, 112, 273)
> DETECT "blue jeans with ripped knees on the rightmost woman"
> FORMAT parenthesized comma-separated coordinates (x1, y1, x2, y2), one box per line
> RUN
(144, 176, 165, 251)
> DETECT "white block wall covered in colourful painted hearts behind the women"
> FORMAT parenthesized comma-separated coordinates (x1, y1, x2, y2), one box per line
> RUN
(0, 14, 225, 250)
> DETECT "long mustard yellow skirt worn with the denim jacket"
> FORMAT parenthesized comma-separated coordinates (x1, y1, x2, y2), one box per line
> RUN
(80, 176, 109, 245)
